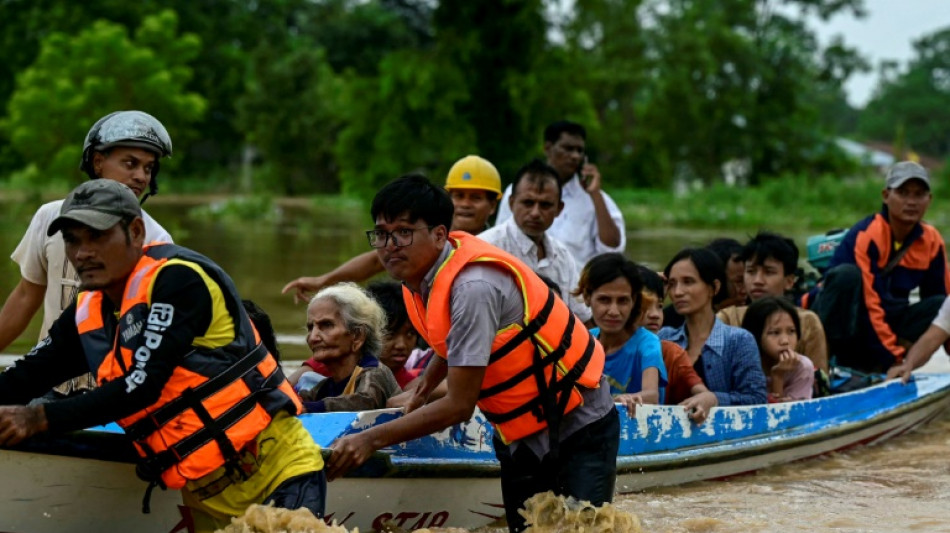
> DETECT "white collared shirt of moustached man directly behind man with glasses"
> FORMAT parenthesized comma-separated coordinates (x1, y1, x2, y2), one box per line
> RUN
(478, 217, 590, 322)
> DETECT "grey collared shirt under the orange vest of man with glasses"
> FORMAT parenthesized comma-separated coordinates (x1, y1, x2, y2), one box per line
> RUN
(412, 238, 614, 458)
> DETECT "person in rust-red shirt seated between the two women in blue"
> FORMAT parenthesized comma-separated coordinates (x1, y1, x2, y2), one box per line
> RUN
(637, 265, 719, 422)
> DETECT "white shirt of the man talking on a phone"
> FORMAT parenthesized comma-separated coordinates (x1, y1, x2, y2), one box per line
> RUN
(495, 175, 627, 268)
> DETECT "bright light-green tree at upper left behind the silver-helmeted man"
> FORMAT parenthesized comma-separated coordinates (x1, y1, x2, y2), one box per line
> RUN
(0, 11, 205, 189)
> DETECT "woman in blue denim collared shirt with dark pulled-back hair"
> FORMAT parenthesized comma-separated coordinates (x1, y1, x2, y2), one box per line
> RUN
(660, 248, 766, 406)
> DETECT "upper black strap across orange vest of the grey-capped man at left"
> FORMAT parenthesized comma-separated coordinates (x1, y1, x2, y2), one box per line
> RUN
(125, 344, 267, 441)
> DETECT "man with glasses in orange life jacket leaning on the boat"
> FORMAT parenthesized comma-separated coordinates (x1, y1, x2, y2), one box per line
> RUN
(328, 176, 619, 531)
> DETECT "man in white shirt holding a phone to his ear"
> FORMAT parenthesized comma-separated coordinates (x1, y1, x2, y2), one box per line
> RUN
(496, 120, 627, 268)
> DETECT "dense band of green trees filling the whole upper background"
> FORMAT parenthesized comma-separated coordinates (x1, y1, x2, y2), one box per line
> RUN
(0, 0, 888, 195)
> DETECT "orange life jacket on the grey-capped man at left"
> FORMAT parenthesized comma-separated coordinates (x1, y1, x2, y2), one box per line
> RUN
(76, 244, 302, 488)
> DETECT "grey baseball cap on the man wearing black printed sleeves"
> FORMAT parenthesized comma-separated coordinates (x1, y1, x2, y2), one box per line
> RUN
(46, 178, 142, 236)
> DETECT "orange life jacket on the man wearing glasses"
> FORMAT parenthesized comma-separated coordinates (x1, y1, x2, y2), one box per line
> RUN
(403, 232, 604, 444)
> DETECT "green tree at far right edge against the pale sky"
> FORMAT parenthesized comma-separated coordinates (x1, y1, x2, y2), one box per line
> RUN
(860, 27, 950, 158)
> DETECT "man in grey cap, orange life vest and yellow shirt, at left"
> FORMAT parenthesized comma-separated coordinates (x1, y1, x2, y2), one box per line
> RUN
(0, 180, 326, 531)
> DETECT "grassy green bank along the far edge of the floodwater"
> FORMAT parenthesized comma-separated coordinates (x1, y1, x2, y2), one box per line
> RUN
(0, 171, 950, 232)
